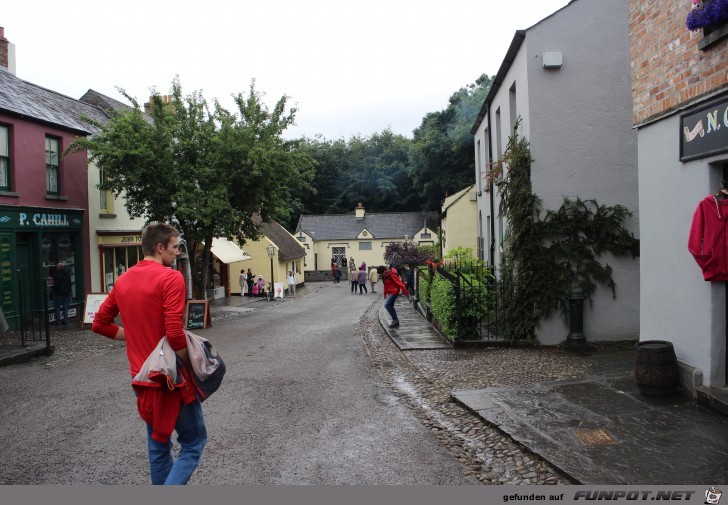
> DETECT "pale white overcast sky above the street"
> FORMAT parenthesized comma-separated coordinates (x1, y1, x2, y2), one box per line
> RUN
(0, 0, 569, 139)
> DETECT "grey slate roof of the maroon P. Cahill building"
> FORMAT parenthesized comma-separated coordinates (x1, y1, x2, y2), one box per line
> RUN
(0, 70, 109, 134)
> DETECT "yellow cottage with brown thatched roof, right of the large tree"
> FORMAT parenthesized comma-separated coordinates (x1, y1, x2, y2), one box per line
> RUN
(229, 221, 306, 295)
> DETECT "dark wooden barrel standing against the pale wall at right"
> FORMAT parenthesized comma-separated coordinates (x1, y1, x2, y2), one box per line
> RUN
(634, 340, 678, 398)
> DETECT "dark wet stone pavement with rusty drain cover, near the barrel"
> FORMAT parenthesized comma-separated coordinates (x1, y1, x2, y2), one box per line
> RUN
(452, 370, 728, 485)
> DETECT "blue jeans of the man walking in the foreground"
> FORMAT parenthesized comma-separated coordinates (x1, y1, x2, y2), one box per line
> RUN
(147, 401, 207, 486)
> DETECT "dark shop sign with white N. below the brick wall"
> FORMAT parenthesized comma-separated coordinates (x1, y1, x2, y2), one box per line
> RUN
(680, 95, 728, 161)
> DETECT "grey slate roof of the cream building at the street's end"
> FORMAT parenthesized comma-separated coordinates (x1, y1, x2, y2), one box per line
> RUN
(296, 211, 438, 240)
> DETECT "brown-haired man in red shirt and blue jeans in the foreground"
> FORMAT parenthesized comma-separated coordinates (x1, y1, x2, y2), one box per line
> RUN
(91, 223, 207, 484)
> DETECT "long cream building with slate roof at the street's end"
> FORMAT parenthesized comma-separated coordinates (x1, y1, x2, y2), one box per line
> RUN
(294, 204, 439, 272)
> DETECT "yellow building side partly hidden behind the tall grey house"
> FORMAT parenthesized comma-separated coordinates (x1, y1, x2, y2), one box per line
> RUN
(440, 184, 478, 257)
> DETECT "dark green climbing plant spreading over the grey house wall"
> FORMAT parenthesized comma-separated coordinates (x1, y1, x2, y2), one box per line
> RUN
(499, 119, 639, 341)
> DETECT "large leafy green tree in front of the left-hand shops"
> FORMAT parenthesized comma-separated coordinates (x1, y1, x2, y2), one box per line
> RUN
(64, 79, 313, 293)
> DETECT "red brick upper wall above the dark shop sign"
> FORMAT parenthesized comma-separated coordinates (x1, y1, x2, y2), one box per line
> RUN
(629, 0, 728, 124)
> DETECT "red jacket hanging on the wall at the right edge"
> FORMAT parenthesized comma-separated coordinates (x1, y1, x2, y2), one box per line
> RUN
(688, 195, 728, 281)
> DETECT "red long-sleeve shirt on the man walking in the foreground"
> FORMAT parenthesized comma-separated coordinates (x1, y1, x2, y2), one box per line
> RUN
(91, 260, 187, 377)
